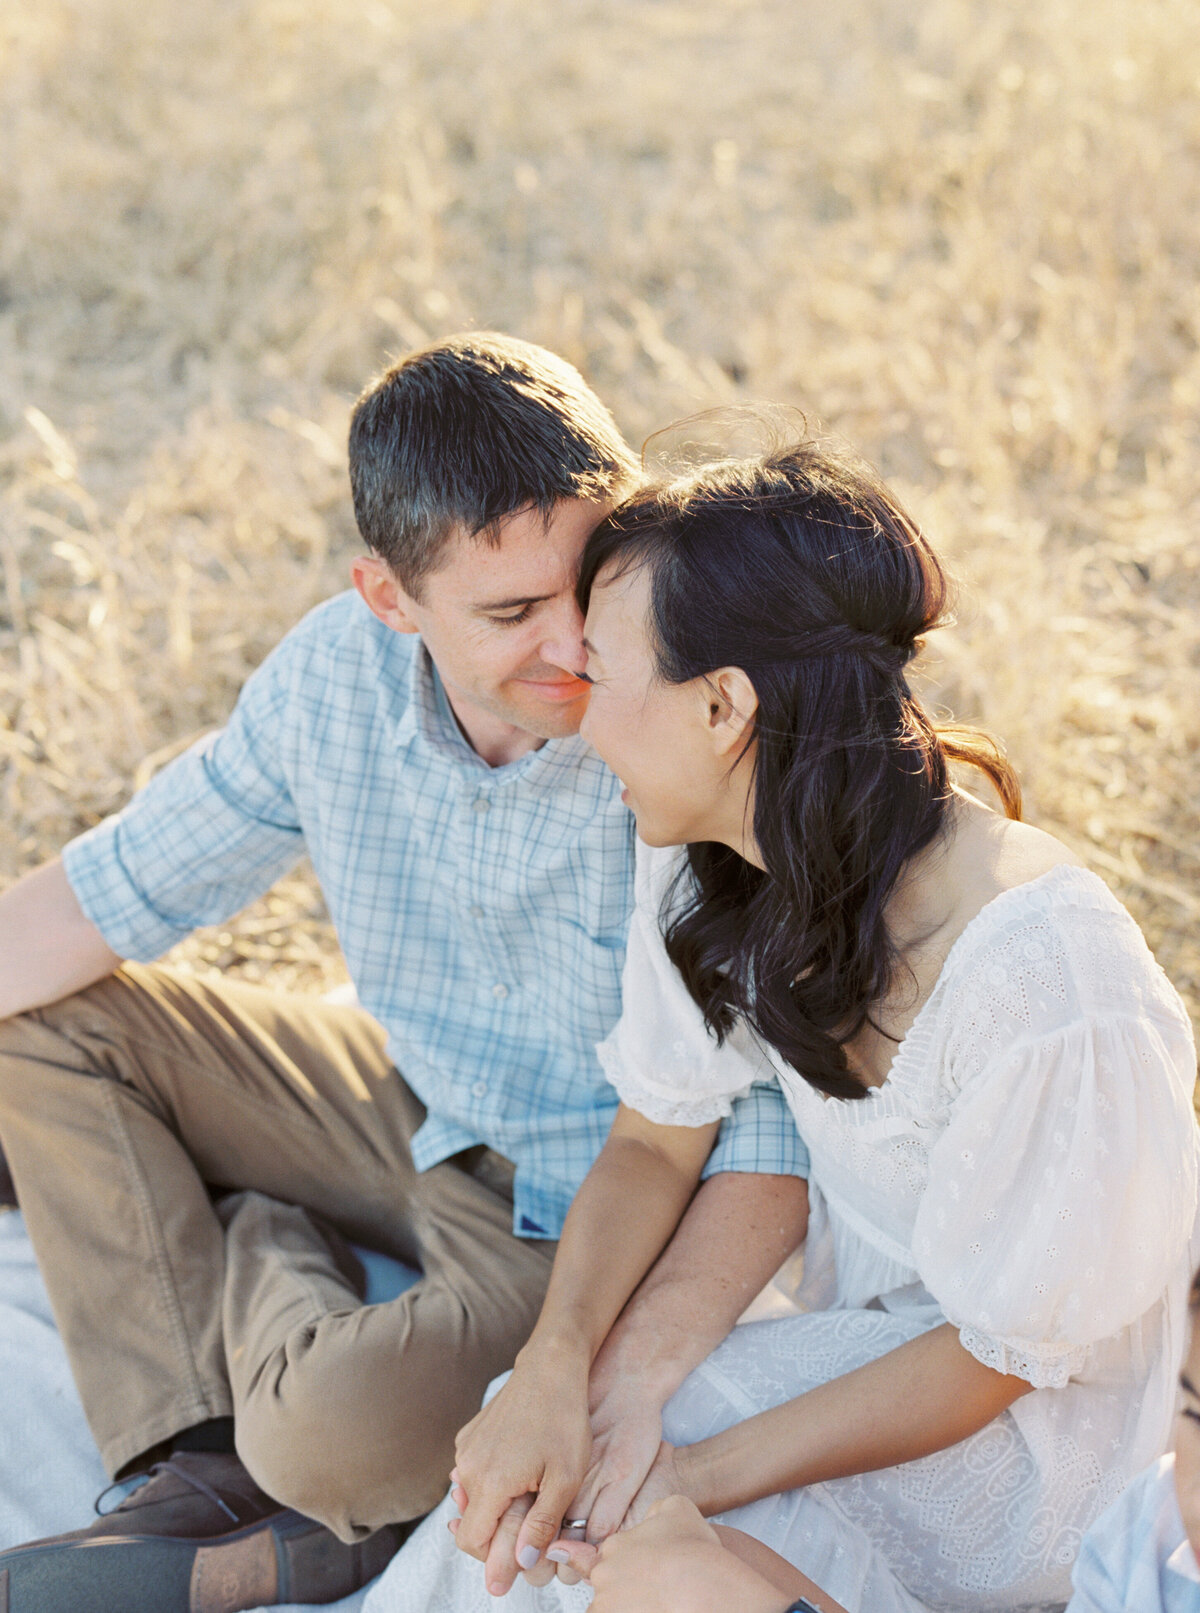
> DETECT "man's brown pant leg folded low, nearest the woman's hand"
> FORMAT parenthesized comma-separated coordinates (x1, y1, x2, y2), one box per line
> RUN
(224, 1157, 556, 1540)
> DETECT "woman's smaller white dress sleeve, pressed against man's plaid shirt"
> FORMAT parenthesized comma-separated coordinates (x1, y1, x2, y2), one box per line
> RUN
(597, 840, 774, 1126)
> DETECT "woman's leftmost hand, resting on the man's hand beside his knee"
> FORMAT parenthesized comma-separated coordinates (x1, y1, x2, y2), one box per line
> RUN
(455, 1357, 592, 1597)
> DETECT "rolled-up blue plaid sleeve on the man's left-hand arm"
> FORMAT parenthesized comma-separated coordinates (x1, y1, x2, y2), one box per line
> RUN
(63, 640, 305, 963)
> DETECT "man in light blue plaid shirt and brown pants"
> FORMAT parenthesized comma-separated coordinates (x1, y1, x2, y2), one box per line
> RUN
(0, 334, 806, 1613)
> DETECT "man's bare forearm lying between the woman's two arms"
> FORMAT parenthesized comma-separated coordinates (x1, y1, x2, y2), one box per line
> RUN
(568, 1171, 808, 1544)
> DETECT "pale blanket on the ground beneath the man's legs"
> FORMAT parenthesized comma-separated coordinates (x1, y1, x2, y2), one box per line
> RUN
(0, 1211, 404, 1613)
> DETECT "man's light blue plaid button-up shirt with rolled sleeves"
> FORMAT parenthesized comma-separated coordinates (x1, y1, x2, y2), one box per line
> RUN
(63, 594, 806, 1237)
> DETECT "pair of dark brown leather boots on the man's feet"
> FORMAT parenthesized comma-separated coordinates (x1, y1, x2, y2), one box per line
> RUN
(0, 1452, 411, 1613)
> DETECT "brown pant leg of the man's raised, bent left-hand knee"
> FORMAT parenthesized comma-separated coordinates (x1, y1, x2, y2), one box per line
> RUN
(0, 965, 423, 1473)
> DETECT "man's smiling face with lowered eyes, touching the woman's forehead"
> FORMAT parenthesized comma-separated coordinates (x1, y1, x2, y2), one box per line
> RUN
(355, 500, 611, 760)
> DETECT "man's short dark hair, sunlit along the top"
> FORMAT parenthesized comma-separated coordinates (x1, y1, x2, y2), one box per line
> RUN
(350, 331, 639, 598)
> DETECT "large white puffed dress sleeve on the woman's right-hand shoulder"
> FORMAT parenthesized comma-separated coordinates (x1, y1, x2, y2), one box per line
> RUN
(913, 876, 1197, 1389)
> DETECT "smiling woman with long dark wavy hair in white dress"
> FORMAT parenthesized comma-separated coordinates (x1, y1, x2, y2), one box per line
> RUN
(366, 444, 1197, 1613)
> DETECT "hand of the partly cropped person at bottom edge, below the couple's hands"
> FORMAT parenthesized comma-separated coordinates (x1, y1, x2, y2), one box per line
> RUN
(548, 1490, 790, 1613)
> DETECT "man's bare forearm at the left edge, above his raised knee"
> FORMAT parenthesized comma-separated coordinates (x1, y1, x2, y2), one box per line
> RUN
(0, 858, 121, 1019)
